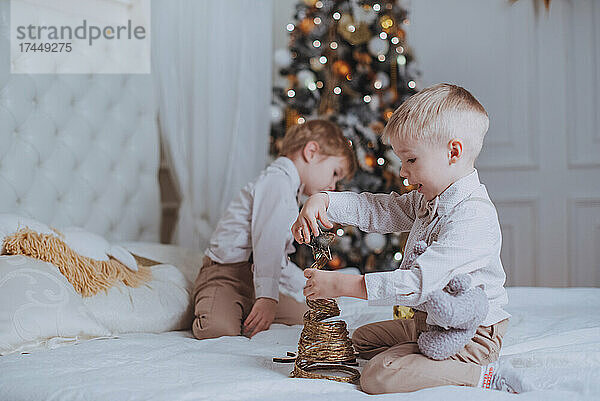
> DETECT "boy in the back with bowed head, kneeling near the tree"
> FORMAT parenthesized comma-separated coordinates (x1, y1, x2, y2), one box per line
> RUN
(192, 120, 356, 339)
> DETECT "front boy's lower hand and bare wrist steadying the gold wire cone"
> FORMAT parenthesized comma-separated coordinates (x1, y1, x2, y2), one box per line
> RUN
(304, 269, 367, 300)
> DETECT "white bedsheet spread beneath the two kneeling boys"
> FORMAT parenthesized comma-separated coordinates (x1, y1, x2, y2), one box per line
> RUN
(0, 288, 600, 401)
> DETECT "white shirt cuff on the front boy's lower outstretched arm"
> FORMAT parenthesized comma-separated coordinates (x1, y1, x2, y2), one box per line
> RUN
(365, 269, 421, 306)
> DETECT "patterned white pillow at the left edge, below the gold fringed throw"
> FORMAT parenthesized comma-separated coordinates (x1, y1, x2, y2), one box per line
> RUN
(0, 255, 110, 355)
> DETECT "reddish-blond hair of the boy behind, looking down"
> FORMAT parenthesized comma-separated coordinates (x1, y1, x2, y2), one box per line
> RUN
(279, 120, 356, 178)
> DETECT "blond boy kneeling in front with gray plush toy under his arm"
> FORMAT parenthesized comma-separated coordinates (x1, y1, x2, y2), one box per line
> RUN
(292, 84, 526, 394)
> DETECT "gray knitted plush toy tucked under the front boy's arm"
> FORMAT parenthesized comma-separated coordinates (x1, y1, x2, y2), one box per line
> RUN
(414, 241, 489, 360)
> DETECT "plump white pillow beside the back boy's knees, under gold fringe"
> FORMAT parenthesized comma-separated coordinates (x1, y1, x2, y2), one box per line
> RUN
(83, 264, 193, 334)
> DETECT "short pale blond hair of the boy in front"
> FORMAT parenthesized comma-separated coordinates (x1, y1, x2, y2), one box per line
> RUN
(382, 84, 489, 161)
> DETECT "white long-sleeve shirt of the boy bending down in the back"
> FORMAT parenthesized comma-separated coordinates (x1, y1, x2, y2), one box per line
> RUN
(205, 157, 306, 300)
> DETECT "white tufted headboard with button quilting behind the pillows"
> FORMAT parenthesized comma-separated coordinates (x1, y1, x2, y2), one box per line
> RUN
(0, 1, 161, 241)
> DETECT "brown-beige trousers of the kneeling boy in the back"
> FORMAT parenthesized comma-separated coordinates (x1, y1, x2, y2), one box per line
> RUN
(192, 257, 308, 340)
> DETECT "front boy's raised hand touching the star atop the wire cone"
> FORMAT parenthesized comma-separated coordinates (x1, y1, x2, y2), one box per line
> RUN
(292, 193, 333, 244)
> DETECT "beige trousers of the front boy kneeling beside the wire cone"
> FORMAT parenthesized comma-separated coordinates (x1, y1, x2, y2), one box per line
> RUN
(352, 311, 508, 394)
